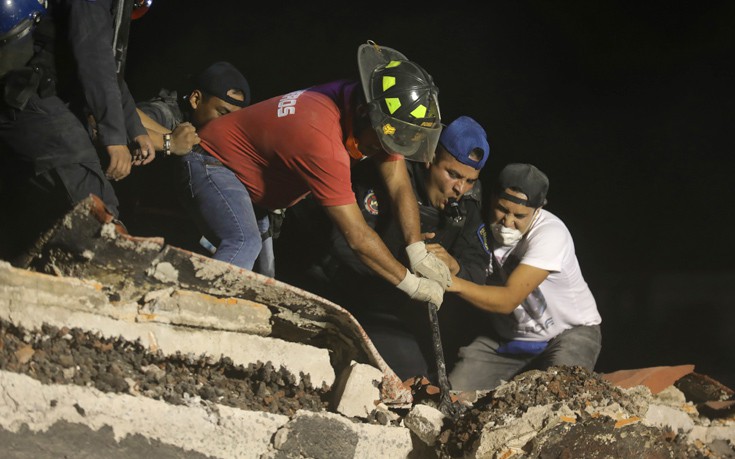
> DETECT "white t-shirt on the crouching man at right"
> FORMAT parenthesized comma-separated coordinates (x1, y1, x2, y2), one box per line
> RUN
(489, 209, 602, 341)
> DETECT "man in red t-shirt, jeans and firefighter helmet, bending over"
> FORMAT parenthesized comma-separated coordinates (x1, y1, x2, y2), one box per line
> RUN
(182, 43, 451, 305)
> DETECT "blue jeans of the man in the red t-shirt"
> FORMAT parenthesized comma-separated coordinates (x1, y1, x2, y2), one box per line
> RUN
(178, 151, 275, 277)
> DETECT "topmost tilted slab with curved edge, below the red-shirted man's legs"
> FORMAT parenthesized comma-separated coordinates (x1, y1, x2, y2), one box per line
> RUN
(18, 196, 412, 406)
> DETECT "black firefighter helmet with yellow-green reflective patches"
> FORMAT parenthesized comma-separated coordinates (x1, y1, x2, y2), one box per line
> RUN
(357, 42, 442, 162)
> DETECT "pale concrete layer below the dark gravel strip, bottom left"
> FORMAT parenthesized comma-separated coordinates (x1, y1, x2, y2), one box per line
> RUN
(0, 371, 288, 458)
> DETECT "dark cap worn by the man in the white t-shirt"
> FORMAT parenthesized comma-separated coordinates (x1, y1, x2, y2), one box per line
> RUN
(497, 163, 549, 208)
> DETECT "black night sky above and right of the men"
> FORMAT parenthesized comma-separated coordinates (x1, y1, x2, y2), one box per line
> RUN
(126, 0, 735, 386)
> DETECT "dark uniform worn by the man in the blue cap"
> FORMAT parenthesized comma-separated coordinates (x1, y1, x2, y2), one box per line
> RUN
(275, 159, 489, 384)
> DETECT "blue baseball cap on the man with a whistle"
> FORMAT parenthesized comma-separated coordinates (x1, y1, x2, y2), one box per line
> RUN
(439, 116, 490, 170)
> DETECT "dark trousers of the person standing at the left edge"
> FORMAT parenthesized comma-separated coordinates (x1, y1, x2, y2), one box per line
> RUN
(0, 95, 118, 259)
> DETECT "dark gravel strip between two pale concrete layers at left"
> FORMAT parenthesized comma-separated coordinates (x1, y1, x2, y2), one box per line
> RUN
(0, 320, 327, 416)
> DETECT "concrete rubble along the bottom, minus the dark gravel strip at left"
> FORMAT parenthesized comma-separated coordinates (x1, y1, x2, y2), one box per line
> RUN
(0, 198, 735, 459)
